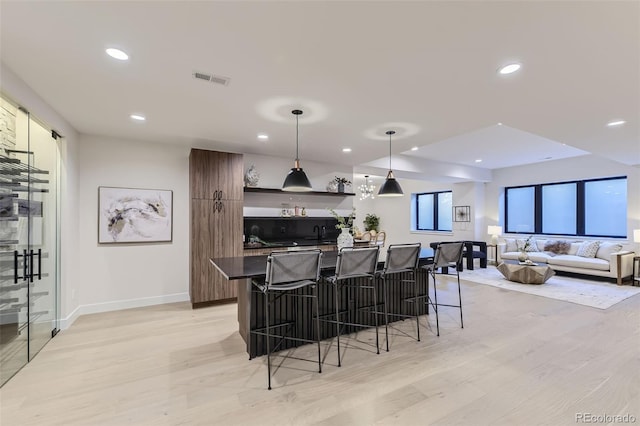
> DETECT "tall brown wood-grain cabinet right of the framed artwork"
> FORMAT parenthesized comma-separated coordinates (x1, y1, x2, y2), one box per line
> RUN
(189, 149, 244, 307)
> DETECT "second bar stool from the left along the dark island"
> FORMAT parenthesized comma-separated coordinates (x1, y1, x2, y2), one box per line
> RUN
(324, 247, 380, 367)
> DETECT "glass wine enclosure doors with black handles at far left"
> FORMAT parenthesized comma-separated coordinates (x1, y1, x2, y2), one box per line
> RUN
(0, 98, 59, 385)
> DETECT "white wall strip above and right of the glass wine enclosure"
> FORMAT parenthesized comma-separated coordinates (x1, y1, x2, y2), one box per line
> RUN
(0, 63, 81, 328)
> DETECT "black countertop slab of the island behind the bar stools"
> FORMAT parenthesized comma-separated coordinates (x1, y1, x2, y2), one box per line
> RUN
(209, 248, 433, 280)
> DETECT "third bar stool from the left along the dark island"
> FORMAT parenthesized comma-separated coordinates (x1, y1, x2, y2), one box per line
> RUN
(378, 243, 422, 352)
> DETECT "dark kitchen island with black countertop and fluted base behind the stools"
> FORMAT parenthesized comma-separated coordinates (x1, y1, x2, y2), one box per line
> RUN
(210, 248, 433, 359)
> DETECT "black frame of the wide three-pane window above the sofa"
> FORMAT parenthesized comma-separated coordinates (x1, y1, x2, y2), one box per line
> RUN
(504, 176, 629, 238)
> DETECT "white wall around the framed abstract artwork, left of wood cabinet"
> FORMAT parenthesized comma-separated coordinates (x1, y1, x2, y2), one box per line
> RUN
(74, 135, 190, 314)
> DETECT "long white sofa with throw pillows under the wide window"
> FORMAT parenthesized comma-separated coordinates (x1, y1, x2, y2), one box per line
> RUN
(498, 237, 635, 285)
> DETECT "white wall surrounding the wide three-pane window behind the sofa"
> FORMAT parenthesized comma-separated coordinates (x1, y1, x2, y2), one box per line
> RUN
(485, 155, 640, 248)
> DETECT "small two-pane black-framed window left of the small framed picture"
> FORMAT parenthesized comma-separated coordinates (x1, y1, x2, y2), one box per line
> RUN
(416, 191, 453, 231)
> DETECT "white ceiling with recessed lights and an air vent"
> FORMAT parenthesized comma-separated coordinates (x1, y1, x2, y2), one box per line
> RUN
(0, 0, 640, 180)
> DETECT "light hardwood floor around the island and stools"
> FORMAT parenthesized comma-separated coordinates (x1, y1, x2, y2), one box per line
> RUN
(0, 276, 640, 426)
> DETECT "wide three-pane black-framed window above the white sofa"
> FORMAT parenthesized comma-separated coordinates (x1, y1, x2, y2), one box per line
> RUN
(505, 177, 627, 238)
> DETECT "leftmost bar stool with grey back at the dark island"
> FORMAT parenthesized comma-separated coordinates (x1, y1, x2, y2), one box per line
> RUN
(251, 250, 322, 390)
